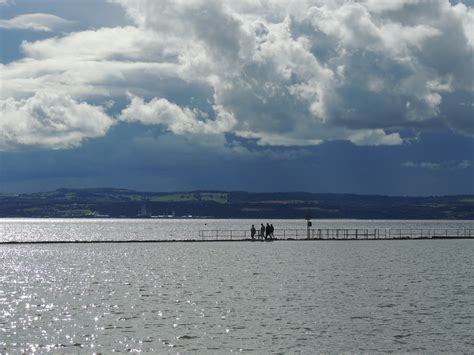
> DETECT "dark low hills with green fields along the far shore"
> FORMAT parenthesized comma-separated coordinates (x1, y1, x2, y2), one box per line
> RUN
(0, 188, 474, 219)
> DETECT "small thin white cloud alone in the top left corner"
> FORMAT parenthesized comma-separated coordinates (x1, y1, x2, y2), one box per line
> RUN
(0, 13, 72, 32)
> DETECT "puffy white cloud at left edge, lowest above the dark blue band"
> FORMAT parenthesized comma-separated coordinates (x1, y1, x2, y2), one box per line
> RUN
(0, 92, 114, 150)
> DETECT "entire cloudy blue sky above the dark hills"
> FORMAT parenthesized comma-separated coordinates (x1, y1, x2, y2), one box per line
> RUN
(0, 0, 474, 196)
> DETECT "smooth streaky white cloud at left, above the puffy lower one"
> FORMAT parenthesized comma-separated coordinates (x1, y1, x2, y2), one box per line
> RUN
(0, 27, 185, 99)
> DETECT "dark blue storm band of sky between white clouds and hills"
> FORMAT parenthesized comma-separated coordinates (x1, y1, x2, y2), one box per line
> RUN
(0, 124, 474, 195)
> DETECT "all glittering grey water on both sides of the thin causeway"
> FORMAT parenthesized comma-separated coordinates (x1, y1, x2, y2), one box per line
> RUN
(0, 219, 474, 353)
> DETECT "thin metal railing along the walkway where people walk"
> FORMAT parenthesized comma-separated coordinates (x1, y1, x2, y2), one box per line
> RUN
(199, 228, 474, 240)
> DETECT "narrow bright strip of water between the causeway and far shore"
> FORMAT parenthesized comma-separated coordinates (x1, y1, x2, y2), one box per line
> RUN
(0, 218, 474, 242)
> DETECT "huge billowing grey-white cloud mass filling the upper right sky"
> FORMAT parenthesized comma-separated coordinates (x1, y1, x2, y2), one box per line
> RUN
(103, 0, 473, 144)
